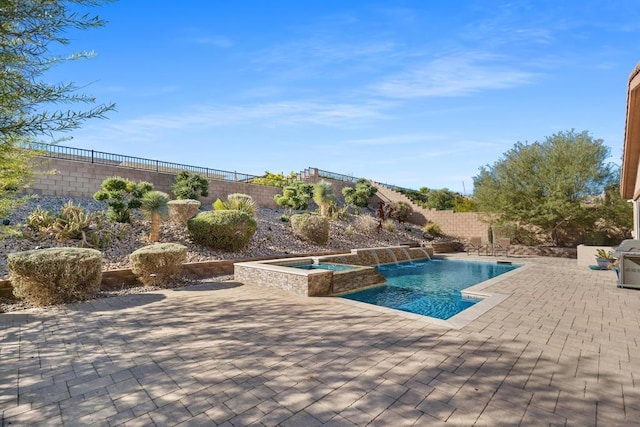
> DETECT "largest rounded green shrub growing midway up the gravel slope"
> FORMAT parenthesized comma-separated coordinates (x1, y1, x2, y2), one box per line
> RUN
(187, 210, 258, 251)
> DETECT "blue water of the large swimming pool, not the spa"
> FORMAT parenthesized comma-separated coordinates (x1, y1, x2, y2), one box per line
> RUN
(342, 259, 518, 320)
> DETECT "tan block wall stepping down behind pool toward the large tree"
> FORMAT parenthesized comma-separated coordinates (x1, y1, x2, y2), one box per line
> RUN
(375, 184, 489, 240)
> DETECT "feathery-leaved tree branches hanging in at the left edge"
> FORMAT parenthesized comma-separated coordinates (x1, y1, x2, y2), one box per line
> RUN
(0, 0, 115, 215)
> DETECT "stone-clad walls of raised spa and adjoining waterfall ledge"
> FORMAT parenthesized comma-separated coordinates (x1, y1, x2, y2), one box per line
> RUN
(234, 246, 433, 297)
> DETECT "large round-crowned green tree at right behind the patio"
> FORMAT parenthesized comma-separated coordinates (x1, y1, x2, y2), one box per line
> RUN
(473, 130, 614, 244)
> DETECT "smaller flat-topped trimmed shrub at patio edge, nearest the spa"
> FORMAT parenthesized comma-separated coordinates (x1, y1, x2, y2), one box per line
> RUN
(129, 243, 187, 286)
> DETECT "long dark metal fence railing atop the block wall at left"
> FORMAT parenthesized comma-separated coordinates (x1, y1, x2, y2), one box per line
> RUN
(31, 144, 259, 182)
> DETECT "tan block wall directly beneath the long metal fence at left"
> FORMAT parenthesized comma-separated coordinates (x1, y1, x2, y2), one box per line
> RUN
(27, 158, 282, 208)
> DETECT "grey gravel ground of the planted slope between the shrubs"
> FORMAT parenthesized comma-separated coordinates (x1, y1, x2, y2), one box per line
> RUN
(0, 196, 436, 311)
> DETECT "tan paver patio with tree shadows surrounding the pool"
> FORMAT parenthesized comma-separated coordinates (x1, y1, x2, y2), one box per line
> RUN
(0, 255, 640, 427)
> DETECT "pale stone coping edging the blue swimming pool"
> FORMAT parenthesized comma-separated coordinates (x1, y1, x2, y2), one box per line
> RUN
(329, 254, 533, 330)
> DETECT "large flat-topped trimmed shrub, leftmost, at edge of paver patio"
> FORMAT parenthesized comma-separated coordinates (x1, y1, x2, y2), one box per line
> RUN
(7, 248, 102, 306)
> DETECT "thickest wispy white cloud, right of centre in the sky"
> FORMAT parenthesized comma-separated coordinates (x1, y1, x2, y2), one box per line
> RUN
(373, 52, 536, 98)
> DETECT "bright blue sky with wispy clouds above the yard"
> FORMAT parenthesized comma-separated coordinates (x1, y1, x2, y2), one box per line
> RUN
(47, 0, 640, 193)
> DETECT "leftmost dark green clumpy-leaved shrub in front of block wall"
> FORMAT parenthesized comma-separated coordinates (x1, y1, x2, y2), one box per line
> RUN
(93, 176, 153, 223)
